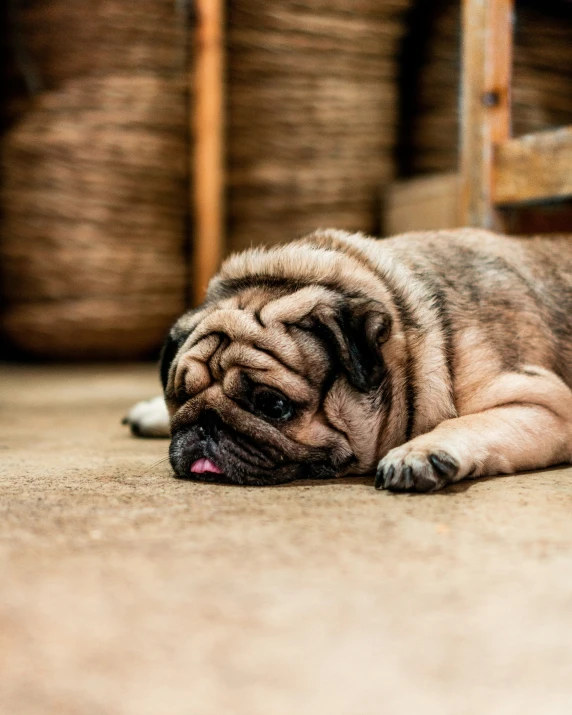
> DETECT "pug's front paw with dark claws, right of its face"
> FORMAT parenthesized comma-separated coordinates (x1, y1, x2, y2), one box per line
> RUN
(375, 443, 460, 492)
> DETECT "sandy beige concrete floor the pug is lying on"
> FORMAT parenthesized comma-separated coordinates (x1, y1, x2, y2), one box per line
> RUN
(0, 366, 572, 715)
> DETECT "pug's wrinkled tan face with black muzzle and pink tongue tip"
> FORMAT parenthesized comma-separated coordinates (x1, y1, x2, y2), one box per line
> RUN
(162, 277, 391, 484)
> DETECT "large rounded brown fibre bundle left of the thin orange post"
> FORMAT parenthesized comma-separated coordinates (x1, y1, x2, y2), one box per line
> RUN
(0, 0, 187, 359)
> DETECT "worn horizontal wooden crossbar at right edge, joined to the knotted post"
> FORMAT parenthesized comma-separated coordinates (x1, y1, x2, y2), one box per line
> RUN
(493, 127, 572, 205)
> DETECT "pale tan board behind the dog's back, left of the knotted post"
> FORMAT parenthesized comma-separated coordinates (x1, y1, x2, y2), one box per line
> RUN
(382, 174, 459, 236)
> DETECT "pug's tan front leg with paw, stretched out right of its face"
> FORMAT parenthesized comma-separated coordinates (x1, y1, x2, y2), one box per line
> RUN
(375, 404, 571, 492)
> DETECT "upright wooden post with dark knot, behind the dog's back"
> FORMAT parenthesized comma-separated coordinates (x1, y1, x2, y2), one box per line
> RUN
(460, 0, 514, 230)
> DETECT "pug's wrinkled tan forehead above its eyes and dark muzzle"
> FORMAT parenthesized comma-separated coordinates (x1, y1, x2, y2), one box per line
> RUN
(174, 287, 326, 397)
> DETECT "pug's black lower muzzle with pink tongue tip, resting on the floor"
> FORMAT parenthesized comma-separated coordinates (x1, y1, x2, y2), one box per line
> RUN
(169, 429, 337, 486)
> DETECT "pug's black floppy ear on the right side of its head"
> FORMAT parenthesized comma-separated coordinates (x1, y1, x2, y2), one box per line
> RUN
(299, 298, 391, 392)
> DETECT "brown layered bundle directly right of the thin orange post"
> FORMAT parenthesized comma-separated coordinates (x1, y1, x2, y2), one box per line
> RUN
(227, 0, 410, 250)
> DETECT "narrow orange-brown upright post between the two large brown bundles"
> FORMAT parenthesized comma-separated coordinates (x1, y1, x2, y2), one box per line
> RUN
(194, 0, 225, 305)
